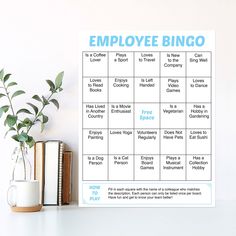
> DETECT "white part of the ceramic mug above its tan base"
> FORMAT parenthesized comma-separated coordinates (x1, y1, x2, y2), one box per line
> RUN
(7, 180, 39, 207)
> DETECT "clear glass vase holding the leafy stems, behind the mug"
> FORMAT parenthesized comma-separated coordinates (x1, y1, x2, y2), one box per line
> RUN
(11, 143, 32, 180)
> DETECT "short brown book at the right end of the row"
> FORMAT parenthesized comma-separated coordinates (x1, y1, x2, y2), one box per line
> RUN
(62, 151, 72, 204)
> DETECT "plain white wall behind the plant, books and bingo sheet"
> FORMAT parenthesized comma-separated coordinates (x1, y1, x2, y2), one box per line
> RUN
(0, 0, 236, 204)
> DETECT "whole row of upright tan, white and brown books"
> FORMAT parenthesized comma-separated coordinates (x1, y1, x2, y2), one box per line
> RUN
(34, 140, 72, 206)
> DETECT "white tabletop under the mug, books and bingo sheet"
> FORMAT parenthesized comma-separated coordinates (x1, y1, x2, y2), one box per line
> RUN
(0, 201, 236, 236)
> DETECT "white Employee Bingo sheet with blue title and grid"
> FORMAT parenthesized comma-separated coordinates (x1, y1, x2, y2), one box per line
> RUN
(79, 31, 215, 207)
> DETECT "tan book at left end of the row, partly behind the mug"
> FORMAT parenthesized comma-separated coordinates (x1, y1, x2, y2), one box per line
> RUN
(34, 141, 45, 204)
